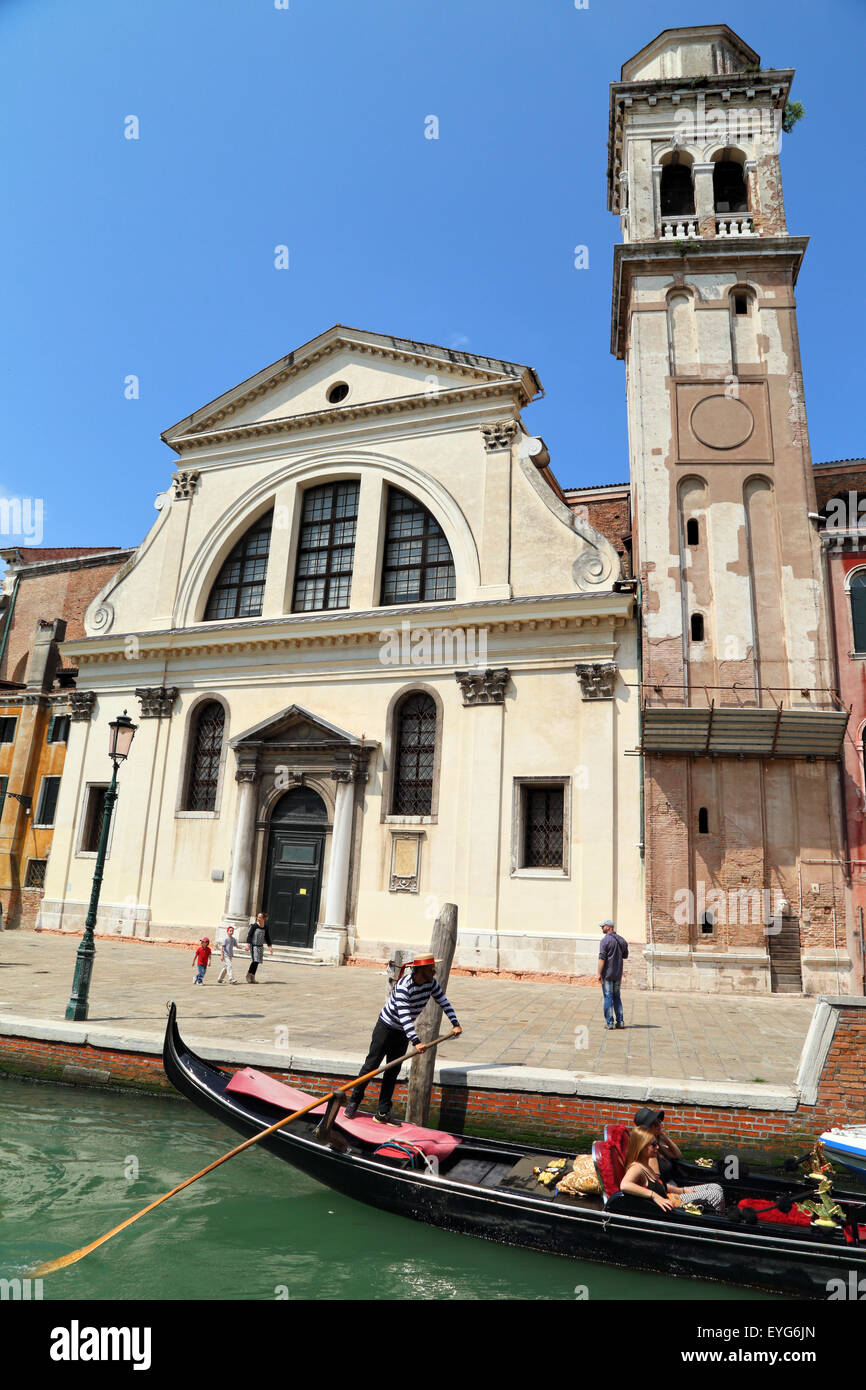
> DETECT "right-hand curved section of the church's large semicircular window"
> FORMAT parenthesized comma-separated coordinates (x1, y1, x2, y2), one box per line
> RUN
(381, 488, 455, 603)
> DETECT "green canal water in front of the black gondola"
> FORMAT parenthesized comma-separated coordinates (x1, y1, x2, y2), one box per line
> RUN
(0, 1079, 763, 1301)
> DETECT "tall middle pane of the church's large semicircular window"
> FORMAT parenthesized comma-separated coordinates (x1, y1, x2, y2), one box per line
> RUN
(292, 480, 360, 613)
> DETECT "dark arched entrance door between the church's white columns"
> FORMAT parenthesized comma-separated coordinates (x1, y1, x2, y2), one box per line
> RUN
(264, 787, 328, 947)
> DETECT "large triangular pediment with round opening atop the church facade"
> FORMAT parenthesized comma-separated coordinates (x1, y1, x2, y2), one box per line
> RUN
(161, 324, 541, 453)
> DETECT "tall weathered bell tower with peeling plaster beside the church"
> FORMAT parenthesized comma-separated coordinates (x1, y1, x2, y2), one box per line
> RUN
(607, 25, 851, 994)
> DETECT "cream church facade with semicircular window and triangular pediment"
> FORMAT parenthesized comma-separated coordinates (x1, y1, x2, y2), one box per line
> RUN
(40, 327, 642, 973)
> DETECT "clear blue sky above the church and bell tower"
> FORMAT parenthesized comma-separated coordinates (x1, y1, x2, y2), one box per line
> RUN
(0, 0, 866, 545)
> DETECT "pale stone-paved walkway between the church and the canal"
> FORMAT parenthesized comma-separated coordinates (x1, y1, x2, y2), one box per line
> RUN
(0, 931, 813, 1086)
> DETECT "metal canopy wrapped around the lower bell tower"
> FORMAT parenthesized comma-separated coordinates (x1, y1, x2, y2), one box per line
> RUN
(641, 703, 848, 758)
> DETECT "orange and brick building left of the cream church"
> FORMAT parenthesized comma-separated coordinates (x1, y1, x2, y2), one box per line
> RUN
(0, 546, 135, 927)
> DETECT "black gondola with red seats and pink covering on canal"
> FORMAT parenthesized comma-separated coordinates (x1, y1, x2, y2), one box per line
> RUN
(163, 1005, 866, 1300)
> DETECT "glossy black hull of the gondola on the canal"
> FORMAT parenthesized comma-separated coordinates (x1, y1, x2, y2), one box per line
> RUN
(164, 1006, 866, 1298)
